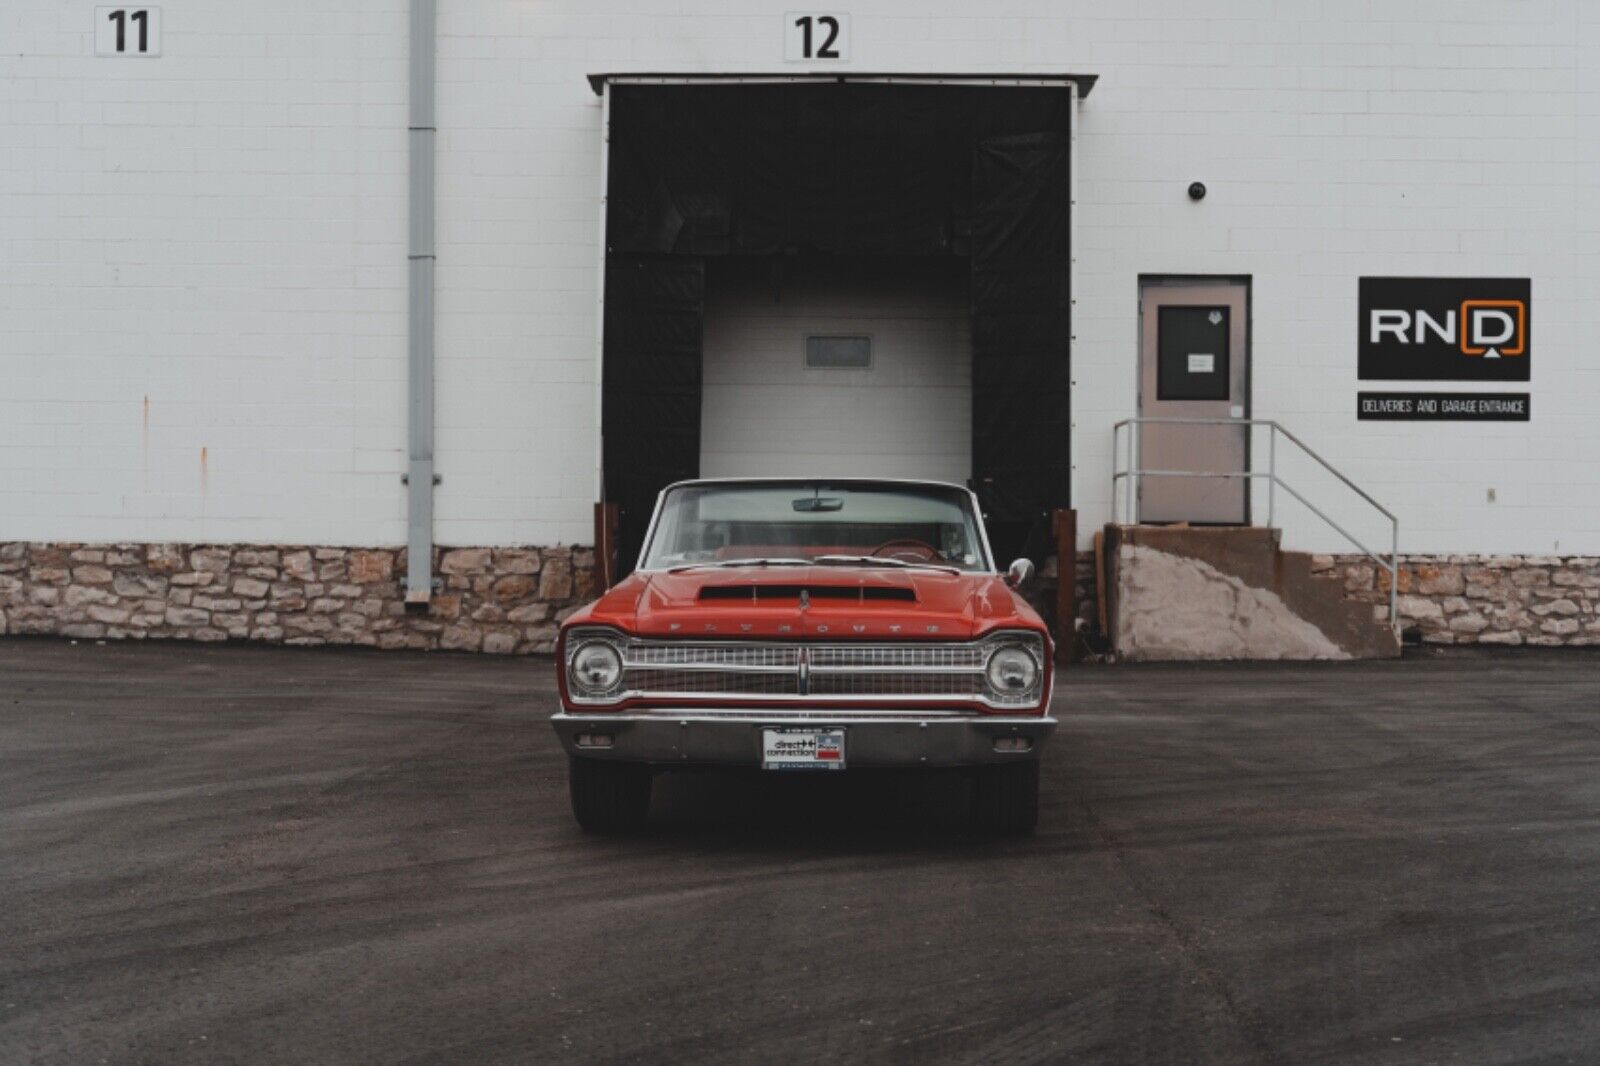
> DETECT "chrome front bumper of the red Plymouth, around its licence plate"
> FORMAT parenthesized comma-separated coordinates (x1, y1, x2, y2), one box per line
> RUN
(550, 707, 1056, 767)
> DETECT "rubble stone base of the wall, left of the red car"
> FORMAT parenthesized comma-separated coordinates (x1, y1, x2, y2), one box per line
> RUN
(0, 543, 594, 655)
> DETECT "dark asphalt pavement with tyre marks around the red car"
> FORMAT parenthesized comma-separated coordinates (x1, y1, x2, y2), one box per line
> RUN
(0, 639, 1600, 1063)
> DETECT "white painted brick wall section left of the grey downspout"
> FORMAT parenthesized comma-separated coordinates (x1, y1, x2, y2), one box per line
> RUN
(0, 0, 405, 543)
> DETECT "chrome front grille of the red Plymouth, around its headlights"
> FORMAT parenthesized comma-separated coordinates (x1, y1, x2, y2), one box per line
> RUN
(566, 629, 1045, 709)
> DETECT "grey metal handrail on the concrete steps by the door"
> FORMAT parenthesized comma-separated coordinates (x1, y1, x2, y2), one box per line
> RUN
(1110, 418, 1400, 627)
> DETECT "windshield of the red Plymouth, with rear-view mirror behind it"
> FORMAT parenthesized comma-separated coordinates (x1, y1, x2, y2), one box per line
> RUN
(645, 482, 990, 570)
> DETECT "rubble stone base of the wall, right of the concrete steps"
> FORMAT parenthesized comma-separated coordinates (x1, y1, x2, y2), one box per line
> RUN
(1314, 555, 1600, 645)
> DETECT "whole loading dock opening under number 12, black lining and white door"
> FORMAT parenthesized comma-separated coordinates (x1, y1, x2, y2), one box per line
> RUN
(597, 75, 1088, 573)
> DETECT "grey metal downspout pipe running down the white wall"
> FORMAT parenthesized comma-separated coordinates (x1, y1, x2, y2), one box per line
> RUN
(405, 0, 437, 608)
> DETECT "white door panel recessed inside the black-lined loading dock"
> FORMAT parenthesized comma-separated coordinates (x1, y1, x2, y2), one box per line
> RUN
(701, 258, 973, 483)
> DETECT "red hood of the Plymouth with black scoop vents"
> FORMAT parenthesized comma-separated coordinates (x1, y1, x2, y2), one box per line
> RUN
(566, 567, 1045, 640)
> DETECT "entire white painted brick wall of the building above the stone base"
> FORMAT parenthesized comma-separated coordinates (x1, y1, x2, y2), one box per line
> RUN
(0, 0, 1600, 552)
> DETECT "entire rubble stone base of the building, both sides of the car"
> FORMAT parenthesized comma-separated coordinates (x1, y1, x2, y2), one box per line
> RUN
(12, 543, 1580, 655)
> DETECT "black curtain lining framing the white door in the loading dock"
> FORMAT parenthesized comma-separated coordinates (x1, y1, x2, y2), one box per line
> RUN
(602, 82, 1070, 573)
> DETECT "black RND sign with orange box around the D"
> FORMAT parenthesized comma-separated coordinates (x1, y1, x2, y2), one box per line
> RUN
(1358, 277, 1533, 381)
